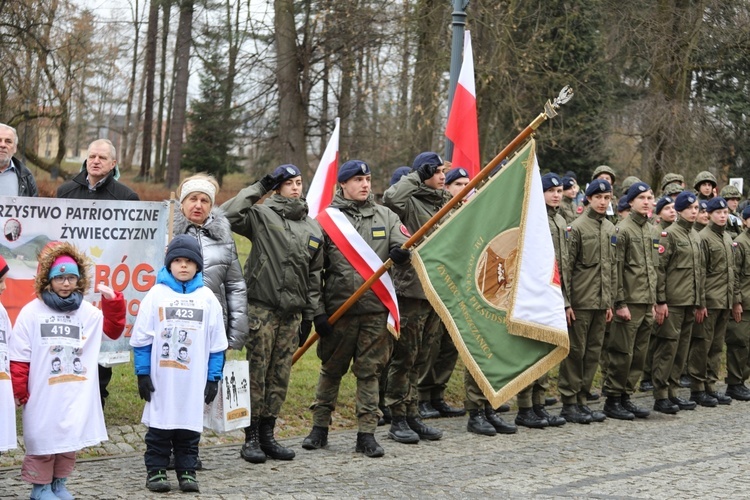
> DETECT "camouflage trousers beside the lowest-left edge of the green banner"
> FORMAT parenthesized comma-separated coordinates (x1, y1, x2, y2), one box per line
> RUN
(385, 297, 442, 417)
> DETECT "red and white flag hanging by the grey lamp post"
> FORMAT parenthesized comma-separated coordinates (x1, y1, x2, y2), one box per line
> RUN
(445, 31, 481, 178)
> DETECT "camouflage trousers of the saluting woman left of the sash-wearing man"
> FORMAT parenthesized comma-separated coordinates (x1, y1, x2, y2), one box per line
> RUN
(246, 304, 302, 421)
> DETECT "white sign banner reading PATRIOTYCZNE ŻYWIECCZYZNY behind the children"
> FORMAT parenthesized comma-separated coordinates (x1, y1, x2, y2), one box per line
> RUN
(0, 196, 169, 366)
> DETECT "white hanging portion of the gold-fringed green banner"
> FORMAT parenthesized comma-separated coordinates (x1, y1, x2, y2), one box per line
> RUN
(508, 155, 568, 336)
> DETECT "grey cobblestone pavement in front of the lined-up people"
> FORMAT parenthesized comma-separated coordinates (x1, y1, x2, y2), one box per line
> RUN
(0, 388, 750, 499)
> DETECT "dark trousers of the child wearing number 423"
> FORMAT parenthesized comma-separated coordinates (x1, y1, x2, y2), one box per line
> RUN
(143, 427, 201, 474)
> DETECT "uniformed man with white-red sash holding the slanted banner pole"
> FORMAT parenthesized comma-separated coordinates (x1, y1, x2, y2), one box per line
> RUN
(302, 160, 410, 457)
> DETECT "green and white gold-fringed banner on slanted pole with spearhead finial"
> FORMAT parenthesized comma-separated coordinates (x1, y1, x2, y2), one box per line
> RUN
(412, 140, 569, 407)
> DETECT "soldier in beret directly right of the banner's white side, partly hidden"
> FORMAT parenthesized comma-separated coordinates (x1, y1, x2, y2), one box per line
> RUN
(516, 173, 570, 429)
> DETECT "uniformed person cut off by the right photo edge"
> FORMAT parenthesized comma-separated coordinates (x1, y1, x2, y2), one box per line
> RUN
(726, 207, 750, 401)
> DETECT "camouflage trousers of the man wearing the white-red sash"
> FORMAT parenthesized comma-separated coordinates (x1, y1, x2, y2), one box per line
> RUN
(312, 313, 393, 434)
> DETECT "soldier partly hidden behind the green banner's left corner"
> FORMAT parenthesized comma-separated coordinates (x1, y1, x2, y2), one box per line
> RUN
(383, 151, 451, 443)
